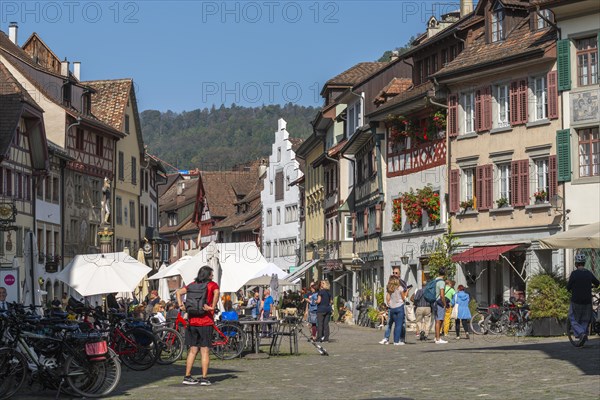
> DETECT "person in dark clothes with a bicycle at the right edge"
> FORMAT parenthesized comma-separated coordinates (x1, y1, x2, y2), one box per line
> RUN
(567, 253, 600, 346)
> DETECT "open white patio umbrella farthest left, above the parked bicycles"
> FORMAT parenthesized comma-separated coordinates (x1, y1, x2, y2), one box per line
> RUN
(56, 252, 150, 296)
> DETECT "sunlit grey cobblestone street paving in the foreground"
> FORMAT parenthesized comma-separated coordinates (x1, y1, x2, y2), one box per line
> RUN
(17, 324, 600, 400)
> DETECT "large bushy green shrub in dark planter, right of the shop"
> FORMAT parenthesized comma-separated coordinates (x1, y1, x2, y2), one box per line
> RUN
(527, 272, 571, 336)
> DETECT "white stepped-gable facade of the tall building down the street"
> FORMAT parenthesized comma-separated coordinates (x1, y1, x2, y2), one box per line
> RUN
(260, 118, 302, 271)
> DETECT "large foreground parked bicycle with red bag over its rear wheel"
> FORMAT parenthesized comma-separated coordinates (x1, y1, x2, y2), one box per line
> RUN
(0, 305, 121, 399)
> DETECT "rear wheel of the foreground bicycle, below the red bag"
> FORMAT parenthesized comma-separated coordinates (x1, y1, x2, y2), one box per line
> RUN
(65, 349, 121, 398)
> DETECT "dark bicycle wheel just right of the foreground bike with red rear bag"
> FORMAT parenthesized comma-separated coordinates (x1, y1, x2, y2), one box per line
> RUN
(115, 328, 159, 371)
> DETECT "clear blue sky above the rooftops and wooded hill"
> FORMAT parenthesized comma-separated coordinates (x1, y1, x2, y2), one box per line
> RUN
(0, 0, 458, 112)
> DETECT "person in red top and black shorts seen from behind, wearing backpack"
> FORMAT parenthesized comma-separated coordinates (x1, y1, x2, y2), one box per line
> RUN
(176, 265, 219, 386)
